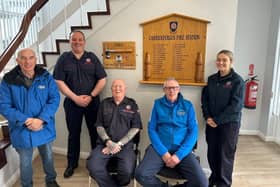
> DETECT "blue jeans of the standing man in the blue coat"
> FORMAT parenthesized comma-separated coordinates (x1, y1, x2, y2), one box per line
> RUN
(16, 143, 56, 187)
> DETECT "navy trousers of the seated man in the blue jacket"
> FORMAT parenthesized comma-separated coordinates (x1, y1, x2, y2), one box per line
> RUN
(135, 145, 208, 187)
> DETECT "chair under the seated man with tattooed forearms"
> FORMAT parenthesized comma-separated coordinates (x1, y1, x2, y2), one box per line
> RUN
(88, 131, 141, 187)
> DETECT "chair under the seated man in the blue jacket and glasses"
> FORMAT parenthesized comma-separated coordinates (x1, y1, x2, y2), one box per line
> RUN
(157, 143, 200, 185)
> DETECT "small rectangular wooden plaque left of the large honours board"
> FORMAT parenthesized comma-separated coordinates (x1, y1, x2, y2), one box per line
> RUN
(103, 41, 136, 69)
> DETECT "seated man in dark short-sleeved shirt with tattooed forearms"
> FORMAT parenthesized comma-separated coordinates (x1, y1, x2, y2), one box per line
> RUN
(87, 80, 142, 187)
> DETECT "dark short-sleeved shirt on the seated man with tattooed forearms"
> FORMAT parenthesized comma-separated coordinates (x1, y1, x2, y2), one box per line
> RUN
(95, 97, 142, 144)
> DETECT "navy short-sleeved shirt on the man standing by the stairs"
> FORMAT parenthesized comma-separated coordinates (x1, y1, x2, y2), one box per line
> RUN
(53, 51, 107, 95)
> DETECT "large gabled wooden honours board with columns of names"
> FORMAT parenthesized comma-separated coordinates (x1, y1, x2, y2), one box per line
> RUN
(141, 14, 209, 85)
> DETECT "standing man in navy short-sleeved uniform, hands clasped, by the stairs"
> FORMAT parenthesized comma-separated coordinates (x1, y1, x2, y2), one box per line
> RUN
(54, 31, 106, 178)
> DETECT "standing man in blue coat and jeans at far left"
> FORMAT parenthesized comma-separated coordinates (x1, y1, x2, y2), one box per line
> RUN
(0, 48, 60, 187)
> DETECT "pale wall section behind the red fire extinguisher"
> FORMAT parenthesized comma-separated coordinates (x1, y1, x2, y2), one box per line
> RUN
(235, 0, 274, 136)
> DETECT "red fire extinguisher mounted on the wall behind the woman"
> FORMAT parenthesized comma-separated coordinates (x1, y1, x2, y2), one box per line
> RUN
(244, 75, 259, 109)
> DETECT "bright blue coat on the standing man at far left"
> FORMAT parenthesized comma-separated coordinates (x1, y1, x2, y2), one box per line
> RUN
(0, 66, 60, 148)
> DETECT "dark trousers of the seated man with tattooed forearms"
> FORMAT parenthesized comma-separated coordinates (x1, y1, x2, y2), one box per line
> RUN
(87, 144, 136, 187)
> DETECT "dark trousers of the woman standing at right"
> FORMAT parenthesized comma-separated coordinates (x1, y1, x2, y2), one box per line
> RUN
(206, 122, 240, 187)
